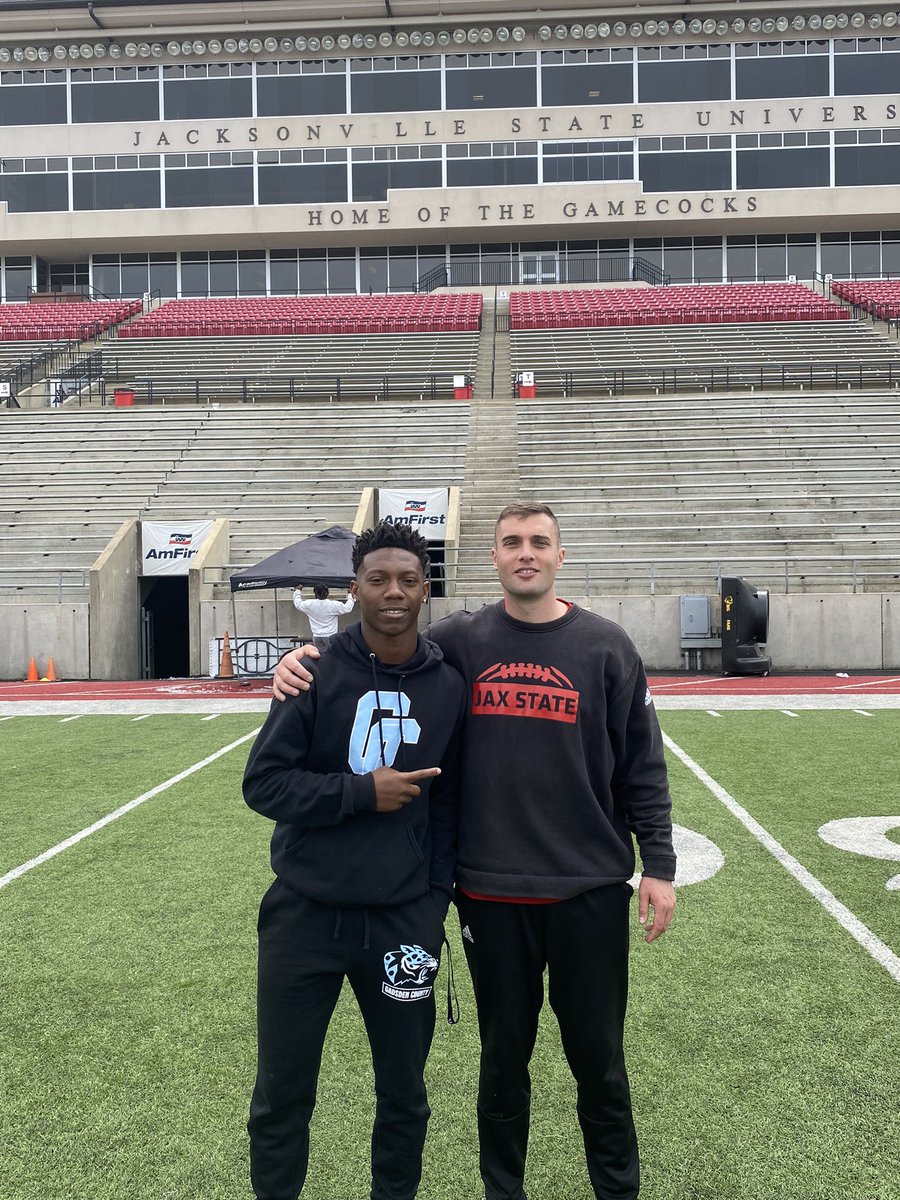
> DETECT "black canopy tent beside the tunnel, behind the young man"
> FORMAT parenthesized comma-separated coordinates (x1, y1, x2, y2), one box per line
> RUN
(230, 526, 356, 674)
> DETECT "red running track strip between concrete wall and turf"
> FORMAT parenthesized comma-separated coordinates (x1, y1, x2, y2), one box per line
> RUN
(0, 672, 900, 701)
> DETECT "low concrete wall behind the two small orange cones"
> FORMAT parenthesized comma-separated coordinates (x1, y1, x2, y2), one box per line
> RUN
(0, 602, 90, 681)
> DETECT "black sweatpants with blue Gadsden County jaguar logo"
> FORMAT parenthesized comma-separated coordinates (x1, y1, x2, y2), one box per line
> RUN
(247, 880, 444, 1200)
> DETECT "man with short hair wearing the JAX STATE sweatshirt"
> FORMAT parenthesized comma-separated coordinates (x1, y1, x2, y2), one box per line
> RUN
(276, 502, 676, 1200)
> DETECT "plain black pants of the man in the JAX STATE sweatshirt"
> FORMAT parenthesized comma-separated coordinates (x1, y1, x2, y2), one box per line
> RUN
(456, 883, 640, 1200)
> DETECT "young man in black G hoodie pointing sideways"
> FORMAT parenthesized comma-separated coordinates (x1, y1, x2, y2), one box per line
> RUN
(244, 524, 464, 1200)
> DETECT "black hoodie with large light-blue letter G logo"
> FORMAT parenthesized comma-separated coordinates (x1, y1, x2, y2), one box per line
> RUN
(244, 625, 466, 912)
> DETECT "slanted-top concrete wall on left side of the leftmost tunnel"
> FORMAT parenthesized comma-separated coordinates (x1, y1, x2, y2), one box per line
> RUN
(89, 521, 140, 679)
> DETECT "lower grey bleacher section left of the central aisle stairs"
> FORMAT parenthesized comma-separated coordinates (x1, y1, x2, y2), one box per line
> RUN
(0, 402, 468, 600)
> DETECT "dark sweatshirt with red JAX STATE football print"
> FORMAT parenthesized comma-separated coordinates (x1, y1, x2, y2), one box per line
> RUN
(427, 602, 676, 900)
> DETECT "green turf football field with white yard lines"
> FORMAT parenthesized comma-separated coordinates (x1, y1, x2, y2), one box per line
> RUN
(0, 701, 900, 1200)
